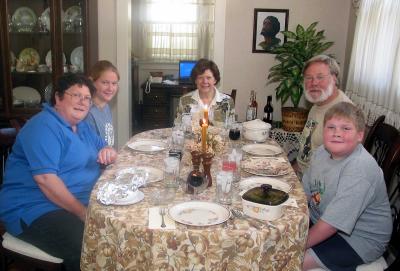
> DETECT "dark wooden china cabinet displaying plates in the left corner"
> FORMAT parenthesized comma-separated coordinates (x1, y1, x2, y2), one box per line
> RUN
(0, 0, 89, 121)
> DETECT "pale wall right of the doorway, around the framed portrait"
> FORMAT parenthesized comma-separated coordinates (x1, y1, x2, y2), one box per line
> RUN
(220, 0, 351, 120)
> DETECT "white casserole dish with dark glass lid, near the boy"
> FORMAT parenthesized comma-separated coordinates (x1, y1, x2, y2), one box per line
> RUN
(242, 184, 289, 220)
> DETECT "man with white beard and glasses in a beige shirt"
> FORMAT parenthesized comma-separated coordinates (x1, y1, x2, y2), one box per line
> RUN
(293, 55, 352, 175)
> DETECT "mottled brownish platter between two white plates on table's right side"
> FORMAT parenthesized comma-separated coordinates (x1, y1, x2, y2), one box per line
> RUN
(241, 157, 290, 177)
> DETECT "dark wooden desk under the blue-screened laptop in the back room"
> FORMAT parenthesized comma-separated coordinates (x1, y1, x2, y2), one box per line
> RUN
(141, 83, 195, 130)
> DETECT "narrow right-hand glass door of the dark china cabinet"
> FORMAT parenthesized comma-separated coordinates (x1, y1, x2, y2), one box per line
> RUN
(62, 0, 86, 73)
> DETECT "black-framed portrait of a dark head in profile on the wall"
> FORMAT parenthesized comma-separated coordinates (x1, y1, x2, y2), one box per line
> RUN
(253, 8, 289, 53)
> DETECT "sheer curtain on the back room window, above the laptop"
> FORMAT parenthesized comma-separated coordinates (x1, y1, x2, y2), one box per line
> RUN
(136, 0, 214, 62)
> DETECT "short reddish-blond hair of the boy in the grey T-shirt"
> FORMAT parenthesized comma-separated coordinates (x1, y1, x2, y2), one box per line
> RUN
(324, 102, 365, 132)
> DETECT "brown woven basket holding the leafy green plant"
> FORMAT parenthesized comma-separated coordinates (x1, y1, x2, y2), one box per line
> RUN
(282, 107, 308, 132)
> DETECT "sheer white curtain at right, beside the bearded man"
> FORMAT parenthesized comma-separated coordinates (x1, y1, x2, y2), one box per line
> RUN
(346, 0, 400, 129)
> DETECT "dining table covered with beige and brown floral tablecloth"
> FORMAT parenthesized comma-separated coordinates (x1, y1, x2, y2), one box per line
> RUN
(80, 128, 309, 271)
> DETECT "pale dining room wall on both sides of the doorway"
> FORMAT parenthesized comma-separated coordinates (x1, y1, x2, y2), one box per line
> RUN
(98, 0, 354, 146)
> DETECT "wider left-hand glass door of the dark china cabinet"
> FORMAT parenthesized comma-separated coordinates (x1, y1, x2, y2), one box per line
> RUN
(7, 0, 53, 112)
